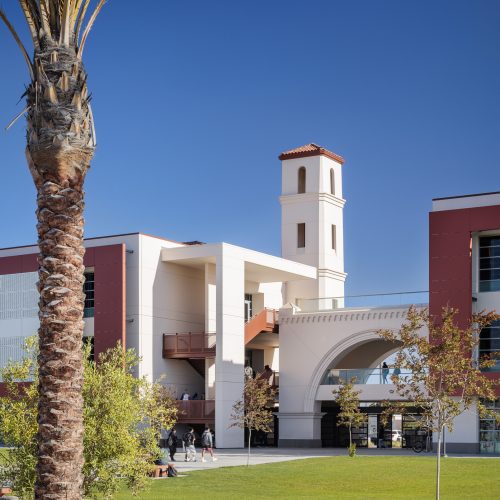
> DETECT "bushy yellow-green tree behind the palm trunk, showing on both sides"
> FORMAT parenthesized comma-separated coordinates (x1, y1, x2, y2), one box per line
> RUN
(0, 338, 177, 498)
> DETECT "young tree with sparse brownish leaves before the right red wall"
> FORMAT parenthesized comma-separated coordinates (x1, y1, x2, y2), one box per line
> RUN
(379, 306, 500, 499)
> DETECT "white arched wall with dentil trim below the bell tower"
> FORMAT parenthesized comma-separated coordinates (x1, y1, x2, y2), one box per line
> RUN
(279, 306, 427, 446)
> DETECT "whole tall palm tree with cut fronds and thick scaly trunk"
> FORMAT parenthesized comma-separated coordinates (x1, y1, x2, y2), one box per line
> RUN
(0, 0, 105, 499)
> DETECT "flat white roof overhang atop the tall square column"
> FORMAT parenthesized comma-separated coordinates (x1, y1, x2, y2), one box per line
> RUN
(161, 243, 317, 283)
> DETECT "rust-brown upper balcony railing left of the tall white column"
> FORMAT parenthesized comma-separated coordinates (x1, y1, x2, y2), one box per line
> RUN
(163, 333, 215, 359)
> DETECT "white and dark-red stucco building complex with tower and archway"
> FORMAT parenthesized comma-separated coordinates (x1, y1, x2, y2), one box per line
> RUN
(0, 144, 500, 452)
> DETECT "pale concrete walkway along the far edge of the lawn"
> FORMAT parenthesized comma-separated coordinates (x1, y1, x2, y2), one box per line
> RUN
(170, 448, 428, 473)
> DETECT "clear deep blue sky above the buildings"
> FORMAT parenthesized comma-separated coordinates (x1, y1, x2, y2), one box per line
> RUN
(0, 0, 500, 294)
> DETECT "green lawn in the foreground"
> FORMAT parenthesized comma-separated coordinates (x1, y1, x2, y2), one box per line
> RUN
(118, 456, 500, 500)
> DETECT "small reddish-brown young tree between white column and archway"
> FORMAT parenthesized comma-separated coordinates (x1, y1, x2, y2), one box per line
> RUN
(231, 377, 276, 466)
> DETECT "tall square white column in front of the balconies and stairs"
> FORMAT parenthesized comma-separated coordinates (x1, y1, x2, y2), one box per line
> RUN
(215, 245, 245, 448)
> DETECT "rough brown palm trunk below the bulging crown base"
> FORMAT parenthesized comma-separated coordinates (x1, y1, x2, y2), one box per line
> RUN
(35, 173, 84, 499)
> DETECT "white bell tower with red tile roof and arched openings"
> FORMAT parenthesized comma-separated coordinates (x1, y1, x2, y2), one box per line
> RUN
(279, 144, 347, 306)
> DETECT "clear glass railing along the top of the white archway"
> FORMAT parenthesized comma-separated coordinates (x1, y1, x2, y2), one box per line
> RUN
(297, 291, 429, 312)
